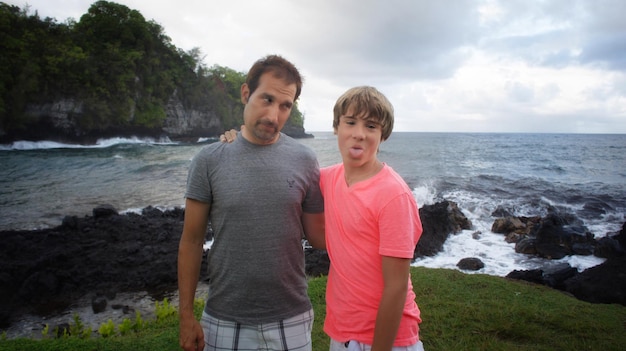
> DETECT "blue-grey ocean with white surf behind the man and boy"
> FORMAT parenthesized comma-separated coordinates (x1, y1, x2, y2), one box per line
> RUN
(0, 132, 626, 276)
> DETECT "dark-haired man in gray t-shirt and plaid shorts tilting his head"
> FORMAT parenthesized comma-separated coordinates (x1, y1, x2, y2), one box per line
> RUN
(178, 55, 325, 351)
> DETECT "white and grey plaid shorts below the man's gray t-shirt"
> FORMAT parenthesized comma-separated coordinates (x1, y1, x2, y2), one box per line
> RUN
(200, 309, 314, 351)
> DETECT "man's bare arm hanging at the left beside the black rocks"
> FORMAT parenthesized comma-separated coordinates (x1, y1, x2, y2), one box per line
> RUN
(178, 199, 211, 351)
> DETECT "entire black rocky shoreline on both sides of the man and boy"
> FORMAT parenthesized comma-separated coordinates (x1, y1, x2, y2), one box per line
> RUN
(0, 201, 626, 337)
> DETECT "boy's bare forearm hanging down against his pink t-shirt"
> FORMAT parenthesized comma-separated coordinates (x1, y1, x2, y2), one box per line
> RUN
(372, 256, 411, 351)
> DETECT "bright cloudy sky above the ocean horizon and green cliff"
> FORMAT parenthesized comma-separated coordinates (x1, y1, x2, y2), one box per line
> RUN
(6, 0, 626, 133)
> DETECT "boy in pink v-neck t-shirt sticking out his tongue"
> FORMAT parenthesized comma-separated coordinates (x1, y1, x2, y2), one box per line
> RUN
(320, 87, 423, 351)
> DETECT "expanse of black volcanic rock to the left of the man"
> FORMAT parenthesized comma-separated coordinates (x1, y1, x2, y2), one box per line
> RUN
(0, 206, 193, 327)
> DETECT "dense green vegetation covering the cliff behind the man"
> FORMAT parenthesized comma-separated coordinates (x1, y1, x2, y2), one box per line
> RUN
(0, 1, 303, 140)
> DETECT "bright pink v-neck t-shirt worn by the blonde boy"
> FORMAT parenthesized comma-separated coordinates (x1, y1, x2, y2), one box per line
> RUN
(320, 164, 422, 346)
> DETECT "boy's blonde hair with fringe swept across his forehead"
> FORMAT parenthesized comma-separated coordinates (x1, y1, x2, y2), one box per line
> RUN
(333, 86, 393, 141)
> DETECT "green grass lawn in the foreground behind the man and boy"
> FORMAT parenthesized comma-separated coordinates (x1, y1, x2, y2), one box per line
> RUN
(0, 267, 626, 351)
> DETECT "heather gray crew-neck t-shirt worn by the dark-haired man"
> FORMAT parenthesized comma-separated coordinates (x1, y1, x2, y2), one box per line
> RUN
(185, 133, 324, 324)
